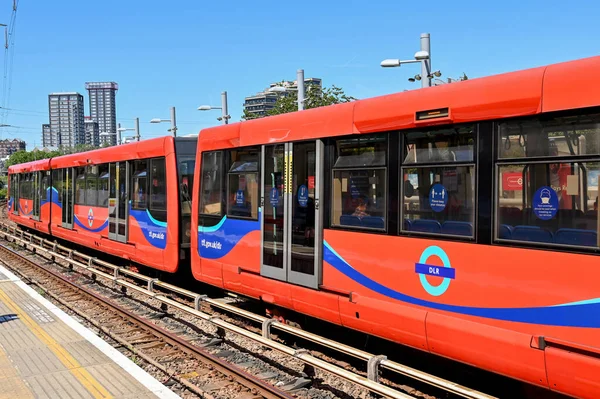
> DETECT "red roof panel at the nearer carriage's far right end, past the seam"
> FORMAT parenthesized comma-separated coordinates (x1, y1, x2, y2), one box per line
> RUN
(542, 57, 600, 112)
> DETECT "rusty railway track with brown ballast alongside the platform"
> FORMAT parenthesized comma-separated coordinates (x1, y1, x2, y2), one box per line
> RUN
(0, 241, 292, 399)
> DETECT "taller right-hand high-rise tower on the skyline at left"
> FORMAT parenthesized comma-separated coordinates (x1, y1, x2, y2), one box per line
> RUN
(85, 82, 119, 145)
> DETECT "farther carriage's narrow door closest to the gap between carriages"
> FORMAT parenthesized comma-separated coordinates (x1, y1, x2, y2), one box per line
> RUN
(108, 162, 129, 242)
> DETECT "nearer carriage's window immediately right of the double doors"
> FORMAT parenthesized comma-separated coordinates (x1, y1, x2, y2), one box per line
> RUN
(331, 135, 387, 230)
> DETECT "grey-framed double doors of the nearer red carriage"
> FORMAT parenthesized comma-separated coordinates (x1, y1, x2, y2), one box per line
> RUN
(261, 140, 323, 288)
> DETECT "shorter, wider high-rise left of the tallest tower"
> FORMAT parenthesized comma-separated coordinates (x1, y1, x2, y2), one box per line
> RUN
(48, 92, 85, 147)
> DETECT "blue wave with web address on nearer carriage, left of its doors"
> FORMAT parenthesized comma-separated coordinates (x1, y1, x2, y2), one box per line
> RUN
(198, 216, 260, 259)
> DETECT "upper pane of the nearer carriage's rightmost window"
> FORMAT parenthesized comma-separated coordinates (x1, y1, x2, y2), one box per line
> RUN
(498, 114, 600, 159)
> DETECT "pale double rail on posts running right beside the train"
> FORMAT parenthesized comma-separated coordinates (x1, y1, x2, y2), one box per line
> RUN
(0, 221, 495, 399)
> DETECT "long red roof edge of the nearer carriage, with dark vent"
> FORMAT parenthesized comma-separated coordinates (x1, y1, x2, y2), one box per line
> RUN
(199, 56, 600, 146)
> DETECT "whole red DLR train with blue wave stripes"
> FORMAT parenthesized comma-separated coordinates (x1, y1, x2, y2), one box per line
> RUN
(9, 57, 600, 398)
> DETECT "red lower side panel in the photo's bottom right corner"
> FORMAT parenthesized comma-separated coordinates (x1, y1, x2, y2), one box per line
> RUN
(545, 346, 600, 399)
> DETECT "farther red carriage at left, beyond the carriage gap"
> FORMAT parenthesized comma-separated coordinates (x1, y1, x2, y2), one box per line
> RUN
(9, 137, 196, 273)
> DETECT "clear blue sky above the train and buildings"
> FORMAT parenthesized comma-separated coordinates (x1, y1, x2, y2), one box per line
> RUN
(0, 0, 600, 148)
